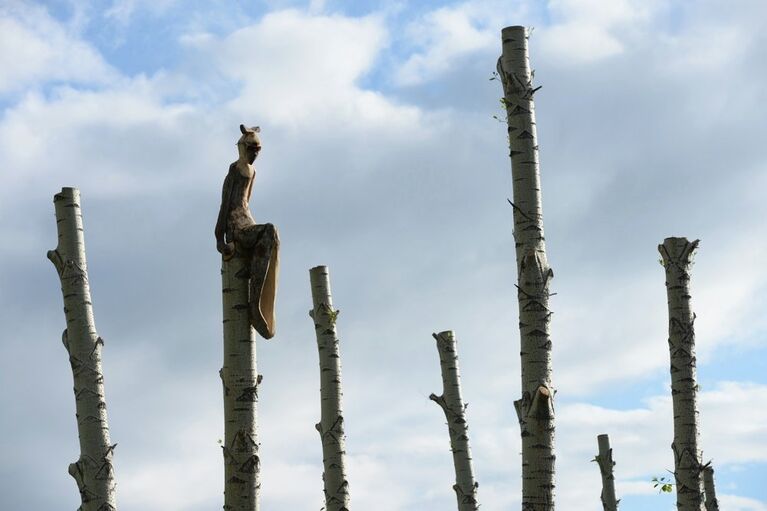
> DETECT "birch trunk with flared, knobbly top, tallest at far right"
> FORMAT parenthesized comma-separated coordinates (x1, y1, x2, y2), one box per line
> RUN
(658, 238, 703, 511)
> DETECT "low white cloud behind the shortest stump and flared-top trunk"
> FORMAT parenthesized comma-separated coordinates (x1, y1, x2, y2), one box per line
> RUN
(557, 382, 767, 495)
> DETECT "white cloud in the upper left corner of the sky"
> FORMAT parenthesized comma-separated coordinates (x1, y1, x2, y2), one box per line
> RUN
(0, 6, 118, 94)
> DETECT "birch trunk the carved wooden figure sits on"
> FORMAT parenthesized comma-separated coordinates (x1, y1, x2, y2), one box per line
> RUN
(219, 254, 261, 511)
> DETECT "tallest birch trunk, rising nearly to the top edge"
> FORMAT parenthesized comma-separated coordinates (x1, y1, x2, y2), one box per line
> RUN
(498, 27, 555, 511)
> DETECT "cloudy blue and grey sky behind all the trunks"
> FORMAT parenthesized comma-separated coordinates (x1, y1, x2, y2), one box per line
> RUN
(0, 0, 767, 511)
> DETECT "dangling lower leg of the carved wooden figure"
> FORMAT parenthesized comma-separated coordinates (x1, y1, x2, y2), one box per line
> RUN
(249, 224, 280, 339)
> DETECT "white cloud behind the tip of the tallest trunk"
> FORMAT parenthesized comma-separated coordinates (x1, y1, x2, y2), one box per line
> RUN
(395, 0, 667, 78)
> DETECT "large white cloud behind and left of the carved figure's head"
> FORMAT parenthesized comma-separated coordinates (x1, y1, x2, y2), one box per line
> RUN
(0, 7, 438, 214)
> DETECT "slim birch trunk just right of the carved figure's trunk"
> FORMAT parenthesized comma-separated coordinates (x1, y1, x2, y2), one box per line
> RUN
(309, 266, 349, 511)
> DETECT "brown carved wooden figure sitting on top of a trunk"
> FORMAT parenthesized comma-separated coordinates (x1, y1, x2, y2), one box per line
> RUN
(215, 124, 280, 339)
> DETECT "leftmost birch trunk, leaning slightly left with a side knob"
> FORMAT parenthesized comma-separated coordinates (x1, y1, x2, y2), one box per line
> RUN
(48, 188, 117, 511)
